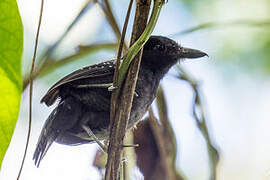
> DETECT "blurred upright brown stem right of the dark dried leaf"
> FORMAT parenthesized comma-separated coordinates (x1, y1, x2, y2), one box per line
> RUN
(136, 86, 184, 180)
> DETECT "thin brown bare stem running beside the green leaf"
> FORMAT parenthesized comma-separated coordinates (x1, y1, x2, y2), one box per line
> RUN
(17, 0, 44, 180)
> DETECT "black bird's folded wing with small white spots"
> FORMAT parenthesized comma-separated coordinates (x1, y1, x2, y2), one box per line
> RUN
(40, 60, 115, 106)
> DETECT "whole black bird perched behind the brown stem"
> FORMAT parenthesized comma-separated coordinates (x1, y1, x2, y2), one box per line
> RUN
(33, 36, 207, 167)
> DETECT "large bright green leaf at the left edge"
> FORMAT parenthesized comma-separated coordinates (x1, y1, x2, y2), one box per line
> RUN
(0, 0, 23, 166)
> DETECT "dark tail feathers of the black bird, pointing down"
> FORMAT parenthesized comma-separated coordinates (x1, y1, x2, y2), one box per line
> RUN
(33, 108, 59, 167)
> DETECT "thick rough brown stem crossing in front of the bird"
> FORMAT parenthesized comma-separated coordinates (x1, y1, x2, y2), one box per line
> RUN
(105, 0, 151, 180)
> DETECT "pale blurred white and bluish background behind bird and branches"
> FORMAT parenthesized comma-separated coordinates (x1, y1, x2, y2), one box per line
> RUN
(0, 0, 270, 180)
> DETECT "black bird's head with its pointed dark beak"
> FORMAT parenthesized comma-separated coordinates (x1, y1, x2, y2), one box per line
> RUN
(142, 36, 207, 73)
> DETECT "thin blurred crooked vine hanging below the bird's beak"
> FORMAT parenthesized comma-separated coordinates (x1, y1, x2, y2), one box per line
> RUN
(178, 66, 219, 180)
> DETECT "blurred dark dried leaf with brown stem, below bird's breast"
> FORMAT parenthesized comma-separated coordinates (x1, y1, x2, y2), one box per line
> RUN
(134, 87, 184, 180)
